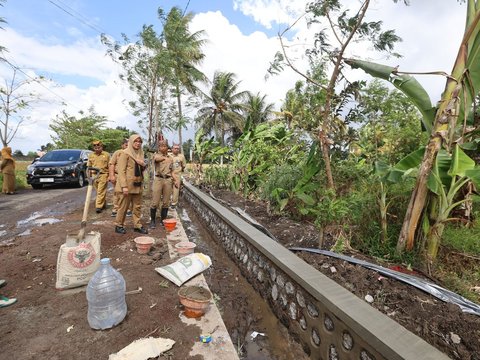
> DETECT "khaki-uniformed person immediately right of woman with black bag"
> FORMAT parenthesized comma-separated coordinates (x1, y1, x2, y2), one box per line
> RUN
(150, 140, 180, 229)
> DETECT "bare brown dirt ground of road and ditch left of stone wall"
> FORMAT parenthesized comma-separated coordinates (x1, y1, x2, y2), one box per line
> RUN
(0, 188, 305, 360)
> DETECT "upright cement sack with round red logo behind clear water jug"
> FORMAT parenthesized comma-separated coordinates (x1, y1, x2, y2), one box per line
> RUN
(55, 232, 101, 290)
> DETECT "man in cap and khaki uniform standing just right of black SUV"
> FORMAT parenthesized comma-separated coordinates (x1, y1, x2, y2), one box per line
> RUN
(87, 140, 110, 214)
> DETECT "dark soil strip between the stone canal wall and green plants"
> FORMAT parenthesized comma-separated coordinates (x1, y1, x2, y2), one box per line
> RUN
(206, 190, 480, 360)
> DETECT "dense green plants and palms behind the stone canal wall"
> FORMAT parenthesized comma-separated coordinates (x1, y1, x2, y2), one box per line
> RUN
(188, 0, 480, 300)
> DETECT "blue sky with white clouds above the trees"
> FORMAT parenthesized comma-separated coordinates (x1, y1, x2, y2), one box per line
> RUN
(0, 0, 466, 153)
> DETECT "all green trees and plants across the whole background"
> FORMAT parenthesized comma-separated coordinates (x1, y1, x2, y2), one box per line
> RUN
(0, 0, 480, 299)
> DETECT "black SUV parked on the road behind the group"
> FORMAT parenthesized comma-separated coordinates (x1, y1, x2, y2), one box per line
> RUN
(27, 149, 91, 189)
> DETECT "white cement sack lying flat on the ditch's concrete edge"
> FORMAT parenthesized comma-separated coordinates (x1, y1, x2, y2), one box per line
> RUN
(155, 253, 212, 286)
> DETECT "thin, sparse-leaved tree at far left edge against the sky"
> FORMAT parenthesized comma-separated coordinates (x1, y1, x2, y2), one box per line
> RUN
(0, 67, 43, 146)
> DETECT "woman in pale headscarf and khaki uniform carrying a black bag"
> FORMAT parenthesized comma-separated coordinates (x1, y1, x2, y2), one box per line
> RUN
(115, 134, 148, 234)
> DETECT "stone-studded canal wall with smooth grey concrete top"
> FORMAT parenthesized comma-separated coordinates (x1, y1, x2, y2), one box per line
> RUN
(183, 182, 449, 360)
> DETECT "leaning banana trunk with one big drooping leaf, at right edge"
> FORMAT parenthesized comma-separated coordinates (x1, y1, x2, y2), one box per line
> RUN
(346, 0, 480, 253)
